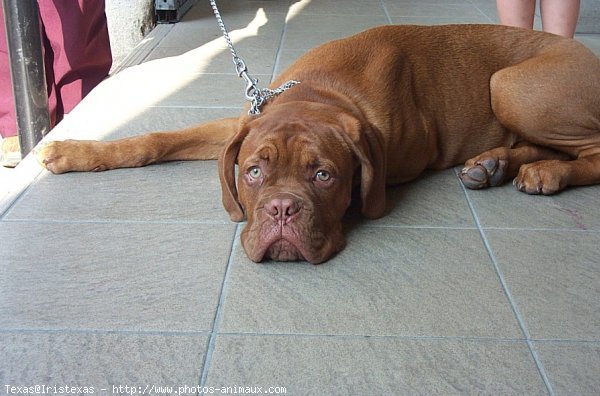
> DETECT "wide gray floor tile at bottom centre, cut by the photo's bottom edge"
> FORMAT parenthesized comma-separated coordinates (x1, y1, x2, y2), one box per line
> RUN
(207, 336, 545, 396)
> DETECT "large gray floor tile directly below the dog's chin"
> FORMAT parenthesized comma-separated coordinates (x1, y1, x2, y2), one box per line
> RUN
(221, 227, 521, 338)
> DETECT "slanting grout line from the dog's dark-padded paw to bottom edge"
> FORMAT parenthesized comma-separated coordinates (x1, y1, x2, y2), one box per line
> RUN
(454, 169, 554, 396)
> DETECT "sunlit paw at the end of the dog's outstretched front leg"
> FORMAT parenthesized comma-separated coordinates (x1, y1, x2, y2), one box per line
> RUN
(35, 140, 99, 174)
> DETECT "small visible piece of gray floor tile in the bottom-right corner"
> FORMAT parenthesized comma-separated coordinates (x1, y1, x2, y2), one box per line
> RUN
(534, 342, 600, 395)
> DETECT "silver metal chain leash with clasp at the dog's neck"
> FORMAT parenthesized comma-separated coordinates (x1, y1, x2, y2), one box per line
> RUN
(209, 0, 300, 115)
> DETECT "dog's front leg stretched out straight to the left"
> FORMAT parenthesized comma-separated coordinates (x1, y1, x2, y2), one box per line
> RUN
(37, 118, 238, 174)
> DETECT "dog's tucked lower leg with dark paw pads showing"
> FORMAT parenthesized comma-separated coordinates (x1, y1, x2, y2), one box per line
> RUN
(459, 144, 570, 190)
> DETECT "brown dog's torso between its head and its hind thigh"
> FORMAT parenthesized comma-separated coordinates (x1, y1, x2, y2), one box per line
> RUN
(273, 25, 600, 181)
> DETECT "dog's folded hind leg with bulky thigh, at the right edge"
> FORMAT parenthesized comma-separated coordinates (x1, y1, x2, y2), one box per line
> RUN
(488, 40, 600, 194)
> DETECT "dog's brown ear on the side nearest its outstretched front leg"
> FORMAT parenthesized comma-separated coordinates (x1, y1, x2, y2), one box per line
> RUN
(218, 124, 250, 222)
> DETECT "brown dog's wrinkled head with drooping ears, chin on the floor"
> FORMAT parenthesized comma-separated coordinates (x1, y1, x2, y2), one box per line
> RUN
(219, 104, 385, 264)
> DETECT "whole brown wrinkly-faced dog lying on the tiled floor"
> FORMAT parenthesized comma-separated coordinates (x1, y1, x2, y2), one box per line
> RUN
(38, 25, 600, 264)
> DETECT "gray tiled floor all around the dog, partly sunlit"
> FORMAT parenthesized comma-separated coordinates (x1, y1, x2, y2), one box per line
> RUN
(0, 0, 600, 395)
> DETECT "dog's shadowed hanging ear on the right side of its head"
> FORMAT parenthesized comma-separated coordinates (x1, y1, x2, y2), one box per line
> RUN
(341, 114, 387, 219)
